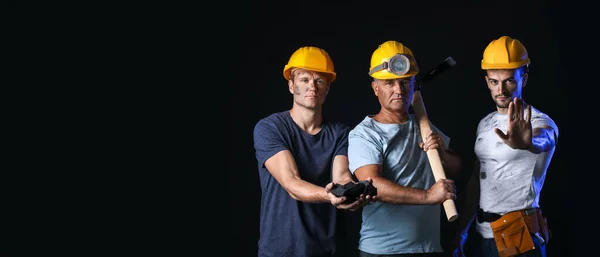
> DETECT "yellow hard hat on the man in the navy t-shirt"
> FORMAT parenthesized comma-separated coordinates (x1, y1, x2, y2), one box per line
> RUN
(283, 46, 336, 83)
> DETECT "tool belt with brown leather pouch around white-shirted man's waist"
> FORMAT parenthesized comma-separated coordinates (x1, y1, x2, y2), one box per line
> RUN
(478, 208, 551, 257)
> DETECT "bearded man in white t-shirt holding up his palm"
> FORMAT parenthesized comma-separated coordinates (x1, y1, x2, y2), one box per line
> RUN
(454, 36, 558, 257)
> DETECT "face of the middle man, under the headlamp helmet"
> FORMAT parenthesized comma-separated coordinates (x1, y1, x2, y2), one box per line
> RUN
(371, 76, 415, 112)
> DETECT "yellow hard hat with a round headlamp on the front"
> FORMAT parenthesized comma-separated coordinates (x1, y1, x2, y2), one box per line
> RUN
(369, 40, 419, 79)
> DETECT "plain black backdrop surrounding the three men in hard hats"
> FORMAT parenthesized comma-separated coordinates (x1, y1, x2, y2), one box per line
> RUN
(0, 0, 598, 257)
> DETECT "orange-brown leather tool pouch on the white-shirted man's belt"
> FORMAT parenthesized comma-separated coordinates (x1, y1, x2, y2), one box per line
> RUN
(490, 211, 537, 257)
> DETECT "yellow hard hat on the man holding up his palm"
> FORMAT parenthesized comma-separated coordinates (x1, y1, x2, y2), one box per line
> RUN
(481, 36, 530, 70)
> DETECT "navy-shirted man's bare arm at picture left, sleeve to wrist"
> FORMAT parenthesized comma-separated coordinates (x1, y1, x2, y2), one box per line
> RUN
(265, 150, 330, 203)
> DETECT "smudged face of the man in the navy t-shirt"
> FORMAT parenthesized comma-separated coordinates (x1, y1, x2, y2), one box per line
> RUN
(288, 69, 329, 109)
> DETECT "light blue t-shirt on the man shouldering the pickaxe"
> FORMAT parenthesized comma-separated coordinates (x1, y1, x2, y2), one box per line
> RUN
(348, 114, 450, 254)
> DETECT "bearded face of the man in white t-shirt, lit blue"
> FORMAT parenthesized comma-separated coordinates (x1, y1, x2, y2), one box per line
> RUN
(485, 69, 527, 109)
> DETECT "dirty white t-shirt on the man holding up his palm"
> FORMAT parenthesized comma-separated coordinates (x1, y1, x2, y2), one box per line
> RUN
(475, 107, 558, 238)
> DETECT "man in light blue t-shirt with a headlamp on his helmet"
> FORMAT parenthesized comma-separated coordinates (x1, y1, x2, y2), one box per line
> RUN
(348, 41, 461, 257)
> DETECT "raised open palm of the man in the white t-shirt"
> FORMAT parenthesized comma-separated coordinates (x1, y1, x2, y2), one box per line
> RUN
(494, 97, 533, 149)
